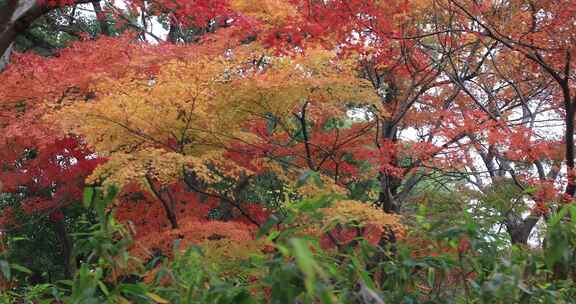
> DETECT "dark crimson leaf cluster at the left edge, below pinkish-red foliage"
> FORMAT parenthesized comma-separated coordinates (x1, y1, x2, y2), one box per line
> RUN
(0, 137, 103, 225)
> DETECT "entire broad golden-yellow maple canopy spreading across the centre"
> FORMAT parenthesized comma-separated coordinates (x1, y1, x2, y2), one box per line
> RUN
(50, 45, 379, 190)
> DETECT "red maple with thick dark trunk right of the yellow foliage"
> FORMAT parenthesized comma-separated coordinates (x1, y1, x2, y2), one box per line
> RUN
(270, 1, 496, 212)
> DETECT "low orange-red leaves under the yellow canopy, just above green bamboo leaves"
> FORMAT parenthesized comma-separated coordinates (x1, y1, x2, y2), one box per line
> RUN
(115, 184, 268, 258)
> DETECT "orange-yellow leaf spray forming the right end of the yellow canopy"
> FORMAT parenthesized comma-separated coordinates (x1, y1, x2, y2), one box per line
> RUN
(230, 49, 380, 123)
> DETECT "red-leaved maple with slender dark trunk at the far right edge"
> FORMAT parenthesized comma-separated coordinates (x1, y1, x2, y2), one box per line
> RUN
(449, 1, 575, 186)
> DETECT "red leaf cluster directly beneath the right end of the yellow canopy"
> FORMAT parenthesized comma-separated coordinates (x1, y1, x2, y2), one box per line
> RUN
(226, 112, 373, 183)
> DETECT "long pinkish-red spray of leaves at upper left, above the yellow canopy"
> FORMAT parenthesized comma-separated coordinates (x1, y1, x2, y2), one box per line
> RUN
(0, 33, 216, 103)
